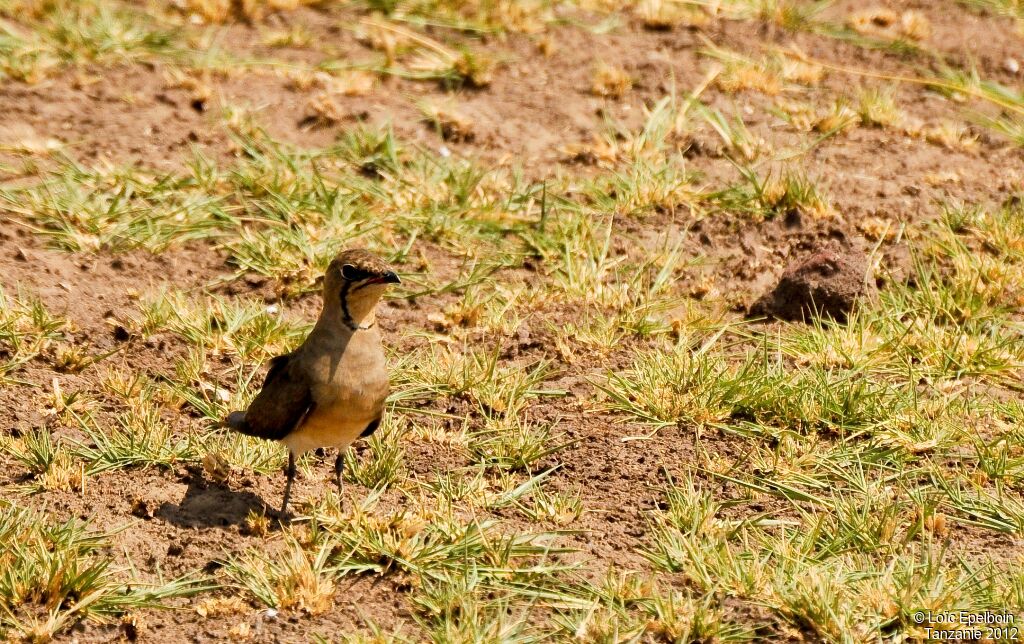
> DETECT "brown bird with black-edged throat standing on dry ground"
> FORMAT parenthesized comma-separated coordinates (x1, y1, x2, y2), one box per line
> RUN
(223, 249, 401, 516)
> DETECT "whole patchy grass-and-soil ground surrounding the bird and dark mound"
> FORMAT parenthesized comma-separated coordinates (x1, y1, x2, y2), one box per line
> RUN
(0, 0, 1024, 643)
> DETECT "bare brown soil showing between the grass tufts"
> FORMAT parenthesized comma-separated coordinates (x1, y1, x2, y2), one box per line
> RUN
(0, 2, 1024, 642)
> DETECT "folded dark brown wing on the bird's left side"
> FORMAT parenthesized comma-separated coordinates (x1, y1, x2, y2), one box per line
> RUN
(242, 353, 314, 440)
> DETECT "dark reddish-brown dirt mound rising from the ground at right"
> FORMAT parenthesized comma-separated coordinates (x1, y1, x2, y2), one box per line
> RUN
(750, 249, 867, 321)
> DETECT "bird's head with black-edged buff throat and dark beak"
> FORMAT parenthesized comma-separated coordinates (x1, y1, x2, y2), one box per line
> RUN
(324, 249, 401, 329)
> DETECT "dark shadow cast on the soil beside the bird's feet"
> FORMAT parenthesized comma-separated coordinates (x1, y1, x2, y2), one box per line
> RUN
(156, 469, 278, 528)
